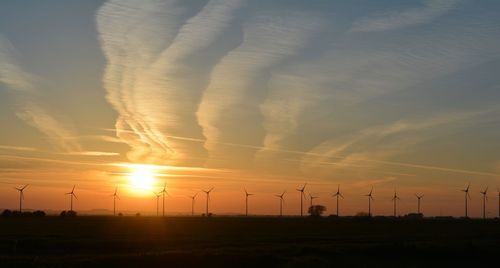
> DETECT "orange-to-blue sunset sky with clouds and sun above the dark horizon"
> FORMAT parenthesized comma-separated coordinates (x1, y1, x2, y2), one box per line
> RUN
(0, 0, 500, 217)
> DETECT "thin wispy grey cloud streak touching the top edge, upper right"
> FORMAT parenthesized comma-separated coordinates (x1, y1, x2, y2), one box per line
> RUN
(351, 0, 459, 32)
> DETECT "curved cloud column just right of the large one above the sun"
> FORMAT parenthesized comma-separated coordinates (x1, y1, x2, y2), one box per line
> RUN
(197, 12, 320, 164)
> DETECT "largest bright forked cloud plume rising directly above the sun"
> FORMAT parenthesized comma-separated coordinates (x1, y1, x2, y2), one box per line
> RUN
(97, 0, 243, 162)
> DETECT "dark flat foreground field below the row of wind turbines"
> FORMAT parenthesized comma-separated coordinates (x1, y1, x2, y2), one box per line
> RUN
(0, 217, 500, 268)
